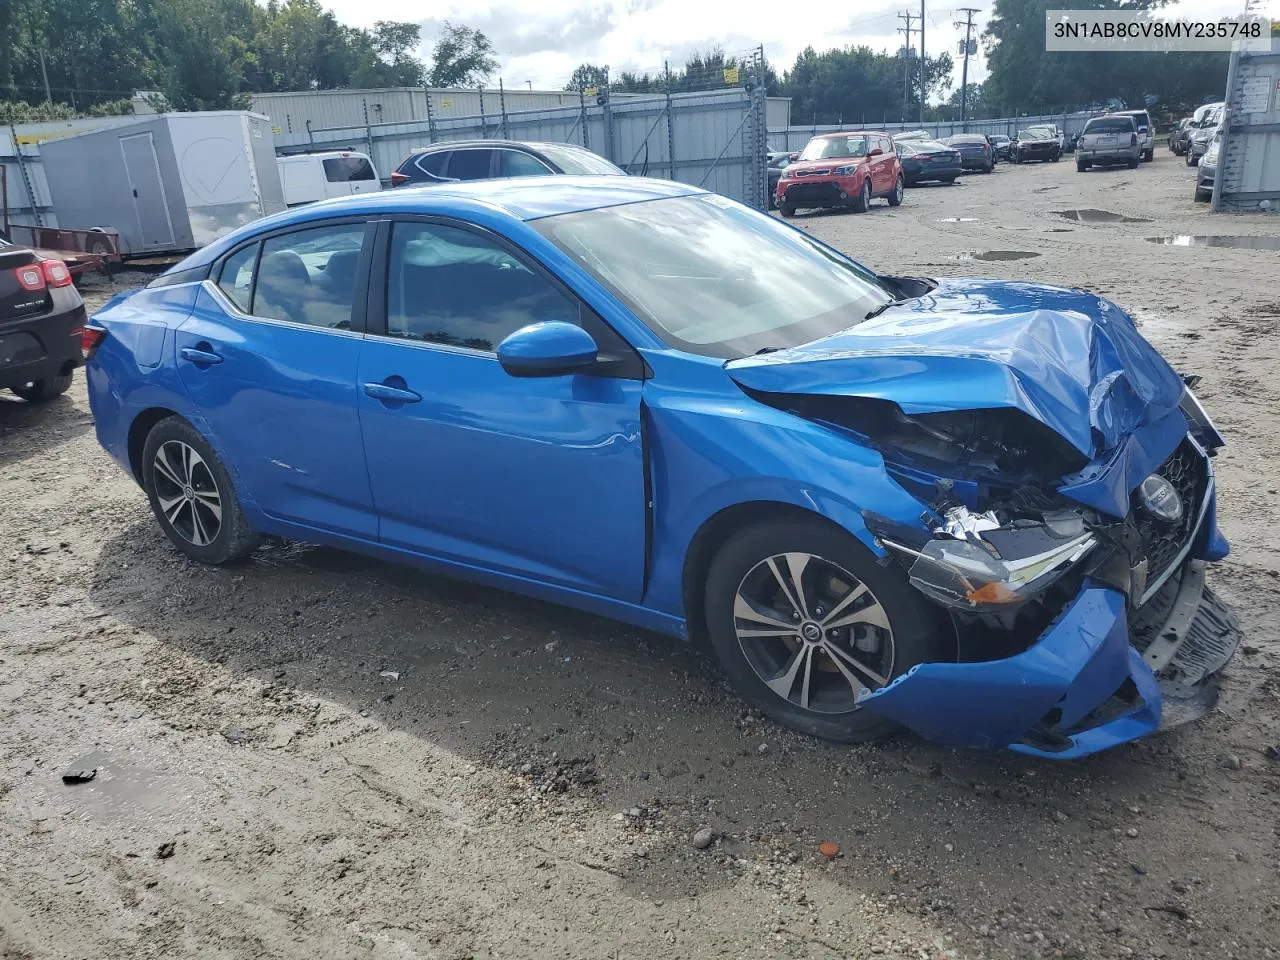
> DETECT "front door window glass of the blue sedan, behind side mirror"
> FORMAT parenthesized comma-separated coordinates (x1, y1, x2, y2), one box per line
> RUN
(387, 223, 579, 351)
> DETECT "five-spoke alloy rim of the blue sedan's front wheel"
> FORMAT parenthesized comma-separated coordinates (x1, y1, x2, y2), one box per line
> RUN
(733, 553, 893, 714)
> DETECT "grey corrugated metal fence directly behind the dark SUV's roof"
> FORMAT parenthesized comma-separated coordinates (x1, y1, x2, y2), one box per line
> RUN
(275, 86, 767, 209)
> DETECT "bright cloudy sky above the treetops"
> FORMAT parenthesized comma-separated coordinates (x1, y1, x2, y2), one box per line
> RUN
(323, 0, 1280, 90)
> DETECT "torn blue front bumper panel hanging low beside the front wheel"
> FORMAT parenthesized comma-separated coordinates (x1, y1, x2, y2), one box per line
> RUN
(859, 585, 1160, 759)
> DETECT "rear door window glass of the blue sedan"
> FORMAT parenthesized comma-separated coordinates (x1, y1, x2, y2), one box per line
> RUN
(252, 223, 365, 329)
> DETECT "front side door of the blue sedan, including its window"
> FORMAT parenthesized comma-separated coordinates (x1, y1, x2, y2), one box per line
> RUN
(357, 220, 645, 600)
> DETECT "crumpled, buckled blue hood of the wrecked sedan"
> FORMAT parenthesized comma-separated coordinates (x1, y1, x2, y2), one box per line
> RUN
(727, 279, 1183, 460)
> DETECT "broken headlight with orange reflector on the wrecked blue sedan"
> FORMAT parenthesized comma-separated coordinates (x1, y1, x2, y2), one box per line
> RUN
(884, 507, 1097, 613)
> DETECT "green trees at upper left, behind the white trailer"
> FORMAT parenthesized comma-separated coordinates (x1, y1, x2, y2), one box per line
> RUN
(0, 0, 435, 115)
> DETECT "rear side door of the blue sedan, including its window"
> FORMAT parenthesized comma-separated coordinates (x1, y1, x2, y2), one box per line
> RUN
(174, 221, 378, 540)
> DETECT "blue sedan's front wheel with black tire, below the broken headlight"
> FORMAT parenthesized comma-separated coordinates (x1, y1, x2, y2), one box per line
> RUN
(704, 520, 948, 742)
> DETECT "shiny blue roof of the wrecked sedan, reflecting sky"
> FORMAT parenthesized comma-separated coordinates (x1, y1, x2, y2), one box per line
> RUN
(173, 176, 707, 270)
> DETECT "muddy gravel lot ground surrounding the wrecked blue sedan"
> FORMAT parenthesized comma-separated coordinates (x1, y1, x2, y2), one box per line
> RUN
(0, 148, 1280, 960)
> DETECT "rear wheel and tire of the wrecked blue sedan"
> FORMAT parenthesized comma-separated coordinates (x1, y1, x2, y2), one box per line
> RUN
(142, 416, 262, 566)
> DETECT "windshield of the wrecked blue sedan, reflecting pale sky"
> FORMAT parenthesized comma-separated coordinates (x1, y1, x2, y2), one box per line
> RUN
(532, 195, 895, 358)
